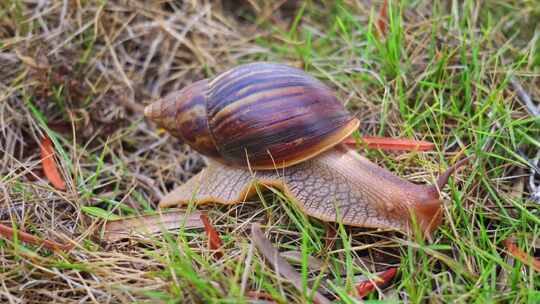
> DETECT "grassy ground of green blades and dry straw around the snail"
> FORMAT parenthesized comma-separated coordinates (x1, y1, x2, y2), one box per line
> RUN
(0, 0, 540, 303)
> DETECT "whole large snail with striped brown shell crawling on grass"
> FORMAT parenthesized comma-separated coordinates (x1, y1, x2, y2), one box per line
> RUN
(144, 63, 463, 233)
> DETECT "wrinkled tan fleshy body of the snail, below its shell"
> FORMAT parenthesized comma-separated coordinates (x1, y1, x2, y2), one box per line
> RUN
(160, 146, 442, 233)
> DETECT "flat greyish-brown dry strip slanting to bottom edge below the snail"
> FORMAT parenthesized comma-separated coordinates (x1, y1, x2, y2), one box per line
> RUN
(251, 224, 330, 304)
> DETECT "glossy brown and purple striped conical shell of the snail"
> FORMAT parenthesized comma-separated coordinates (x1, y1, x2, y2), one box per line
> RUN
(145, 63, 359, 169)
